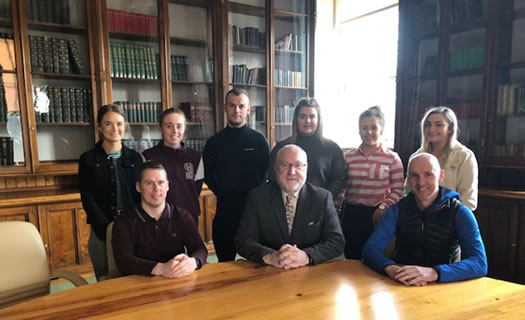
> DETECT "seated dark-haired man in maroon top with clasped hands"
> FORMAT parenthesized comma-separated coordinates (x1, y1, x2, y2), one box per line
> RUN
(112, 161, 208, 278)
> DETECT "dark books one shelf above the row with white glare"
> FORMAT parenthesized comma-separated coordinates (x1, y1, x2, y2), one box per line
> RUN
(29, 35, 86, 74)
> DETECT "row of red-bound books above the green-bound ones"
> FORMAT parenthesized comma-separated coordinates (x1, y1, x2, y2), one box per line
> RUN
(106, 9, 159, 36)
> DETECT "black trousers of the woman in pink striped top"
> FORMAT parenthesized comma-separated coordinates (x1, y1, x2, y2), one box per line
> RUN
(341, 203, 377, 259)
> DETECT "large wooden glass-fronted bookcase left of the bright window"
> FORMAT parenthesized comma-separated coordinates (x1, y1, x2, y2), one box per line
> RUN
(0, 0, 315, 268)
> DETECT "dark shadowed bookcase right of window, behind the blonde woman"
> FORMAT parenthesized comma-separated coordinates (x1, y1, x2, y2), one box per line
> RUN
(395, 0, 525, 283)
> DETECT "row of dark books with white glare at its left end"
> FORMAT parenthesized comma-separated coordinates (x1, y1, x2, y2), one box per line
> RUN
(33, 86, 92, 123)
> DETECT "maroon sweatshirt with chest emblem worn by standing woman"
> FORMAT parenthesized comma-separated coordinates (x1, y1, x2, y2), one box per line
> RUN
(142, 141, 203, 221)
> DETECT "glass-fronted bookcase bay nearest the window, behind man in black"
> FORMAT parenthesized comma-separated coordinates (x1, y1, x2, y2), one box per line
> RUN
(224, 0, 314, 145)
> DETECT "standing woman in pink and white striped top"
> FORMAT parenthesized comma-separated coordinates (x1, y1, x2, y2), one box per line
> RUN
(338, 106, 404, 259)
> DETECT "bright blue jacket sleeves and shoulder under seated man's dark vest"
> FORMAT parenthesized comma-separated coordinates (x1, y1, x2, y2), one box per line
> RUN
(362, 187, 487, 282)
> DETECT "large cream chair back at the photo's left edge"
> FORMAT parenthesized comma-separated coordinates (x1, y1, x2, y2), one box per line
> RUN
(0, 221, 49, 308)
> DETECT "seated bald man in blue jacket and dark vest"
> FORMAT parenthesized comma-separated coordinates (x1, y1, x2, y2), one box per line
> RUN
(362, 153, 487, 286)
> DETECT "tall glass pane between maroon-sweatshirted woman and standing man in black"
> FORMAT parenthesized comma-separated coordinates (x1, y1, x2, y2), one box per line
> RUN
(169, 1, 215, 151)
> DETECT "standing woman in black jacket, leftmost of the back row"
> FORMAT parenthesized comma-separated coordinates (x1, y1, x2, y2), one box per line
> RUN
(78, 105, 142, 280)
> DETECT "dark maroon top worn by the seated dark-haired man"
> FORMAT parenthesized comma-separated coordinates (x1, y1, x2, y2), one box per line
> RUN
(112, 203, 208, 275)
